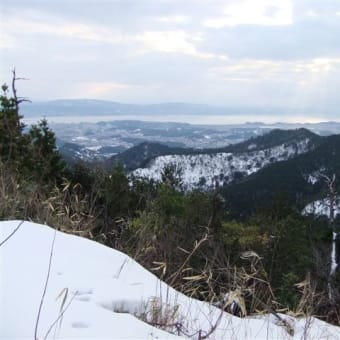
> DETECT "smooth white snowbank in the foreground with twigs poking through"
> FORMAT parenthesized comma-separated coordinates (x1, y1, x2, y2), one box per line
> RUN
(0, 221, 340, 340)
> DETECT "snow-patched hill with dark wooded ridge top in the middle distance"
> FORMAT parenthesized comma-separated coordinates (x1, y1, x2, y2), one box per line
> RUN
(129, 129, 322, 190)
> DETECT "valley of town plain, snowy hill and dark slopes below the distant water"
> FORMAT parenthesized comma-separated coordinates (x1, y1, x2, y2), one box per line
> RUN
(41, 111, 340, 218)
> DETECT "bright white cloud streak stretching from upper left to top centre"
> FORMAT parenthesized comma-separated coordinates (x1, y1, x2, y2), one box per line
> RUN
(0, 10, 226, 60)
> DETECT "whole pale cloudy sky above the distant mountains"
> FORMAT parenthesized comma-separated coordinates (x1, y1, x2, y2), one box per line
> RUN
(0, 0, 340, 121)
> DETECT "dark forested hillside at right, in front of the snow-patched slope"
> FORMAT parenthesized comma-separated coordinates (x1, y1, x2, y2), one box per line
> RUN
(223, 135, 340, 217)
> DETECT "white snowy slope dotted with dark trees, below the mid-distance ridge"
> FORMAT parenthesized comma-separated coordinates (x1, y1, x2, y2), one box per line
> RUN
(133, 139, 309, 190)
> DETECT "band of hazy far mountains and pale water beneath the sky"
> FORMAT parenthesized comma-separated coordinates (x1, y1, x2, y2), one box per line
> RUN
(20, 99, 336, 125)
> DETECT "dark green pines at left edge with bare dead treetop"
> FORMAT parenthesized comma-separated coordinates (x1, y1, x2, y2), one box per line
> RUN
(0, 70, 65, 183)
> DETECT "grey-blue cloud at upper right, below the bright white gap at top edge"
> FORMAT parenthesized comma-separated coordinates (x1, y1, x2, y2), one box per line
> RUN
(199, 17, 340, 60)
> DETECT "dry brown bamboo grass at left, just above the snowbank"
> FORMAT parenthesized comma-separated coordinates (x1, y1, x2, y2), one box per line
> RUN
(0, 165, 96, 238)
